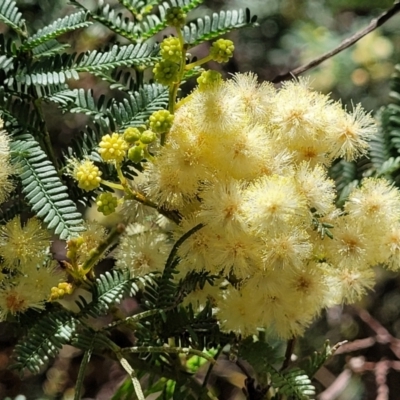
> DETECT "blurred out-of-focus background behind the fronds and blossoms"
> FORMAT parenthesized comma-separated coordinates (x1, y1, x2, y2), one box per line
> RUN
(0, 0, 400, 400)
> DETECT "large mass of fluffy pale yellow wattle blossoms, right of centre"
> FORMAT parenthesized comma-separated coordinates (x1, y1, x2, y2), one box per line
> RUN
(117, 74, 400, 338)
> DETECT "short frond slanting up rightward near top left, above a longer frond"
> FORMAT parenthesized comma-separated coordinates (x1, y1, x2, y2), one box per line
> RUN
(21, 11, 92, 51)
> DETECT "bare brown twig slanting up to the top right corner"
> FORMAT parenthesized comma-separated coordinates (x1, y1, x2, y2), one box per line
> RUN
(272, 1, 400, 83)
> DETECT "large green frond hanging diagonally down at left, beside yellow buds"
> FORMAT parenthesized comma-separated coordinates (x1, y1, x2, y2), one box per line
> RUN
(11, 137, 84, 239)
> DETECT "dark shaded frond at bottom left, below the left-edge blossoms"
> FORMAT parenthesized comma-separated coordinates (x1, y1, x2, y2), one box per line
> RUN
(12, 309, 79, 373)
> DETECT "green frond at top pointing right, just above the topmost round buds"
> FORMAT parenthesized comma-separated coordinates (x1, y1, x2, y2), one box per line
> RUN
(183, 9, 257, 47)
